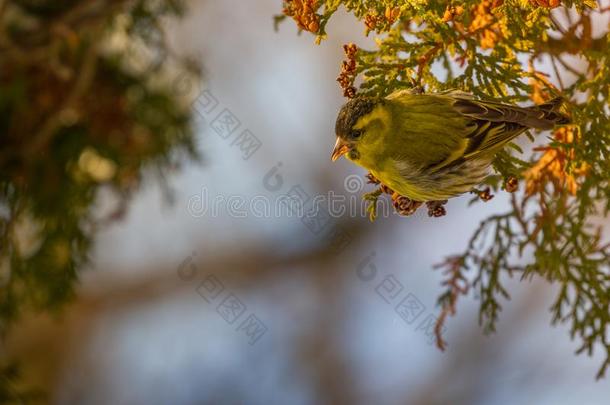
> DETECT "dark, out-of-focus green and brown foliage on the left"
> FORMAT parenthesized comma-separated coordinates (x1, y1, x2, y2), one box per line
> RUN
(0, 0, 198, 396)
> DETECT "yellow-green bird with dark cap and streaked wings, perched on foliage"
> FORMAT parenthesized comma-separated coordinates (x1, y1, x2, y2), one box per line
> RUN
(332, 90, 570, 202)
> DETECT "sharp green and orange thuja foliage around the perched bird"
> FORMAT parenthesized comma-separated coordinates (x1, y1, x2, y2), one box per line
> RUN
(277, 0, 610, 378)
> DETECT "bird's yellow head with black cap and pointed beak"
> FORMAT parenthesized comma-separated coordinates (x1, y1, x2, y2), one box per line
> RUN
(331, 97, 390, 163)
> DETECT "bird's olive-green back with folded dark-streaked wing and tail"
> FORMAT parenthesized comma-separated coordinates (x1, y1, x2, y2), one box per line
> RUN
(388, 91, 569, 172)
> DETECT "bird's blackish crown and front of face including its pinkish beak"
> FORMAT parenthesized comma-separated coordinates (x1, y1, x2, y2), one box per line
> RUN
(331, 97, 379, 161)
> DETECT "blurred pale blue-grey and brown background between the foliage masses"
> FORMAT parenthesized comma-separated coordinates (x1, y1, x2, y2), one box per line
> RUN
(7, 0, 610, 405)
